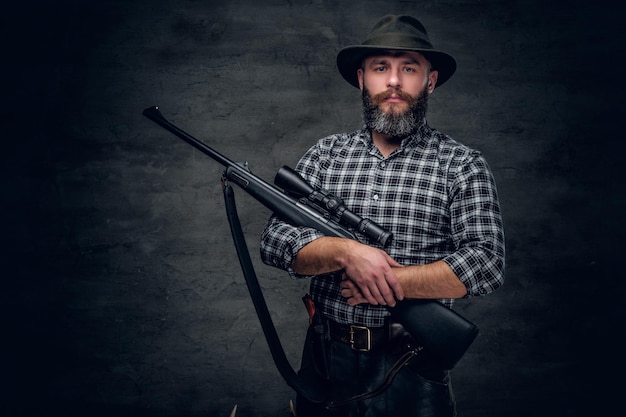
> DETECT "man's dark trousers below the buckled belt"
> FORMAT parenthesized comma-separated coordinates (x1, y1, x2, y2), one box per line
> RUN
(296, 322, 456, 417)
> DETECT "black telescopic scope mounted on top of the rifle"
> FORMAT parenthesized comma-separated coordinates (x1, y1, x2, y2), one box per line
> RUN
(274, 165, 392, 247)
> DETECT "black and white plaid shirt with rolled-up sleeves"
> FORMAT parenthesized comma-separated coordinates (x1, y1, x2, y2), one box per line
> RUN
(260, 124, 504, 327)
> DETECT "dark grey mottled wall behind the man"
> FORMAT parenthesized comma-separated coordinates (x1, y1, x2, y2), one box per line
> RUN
(0, 0, 626, 417)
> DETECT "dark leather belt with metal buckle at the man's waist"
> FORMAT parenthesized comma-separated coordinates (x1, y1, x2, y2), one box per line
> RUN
(328, 320, 390, 352)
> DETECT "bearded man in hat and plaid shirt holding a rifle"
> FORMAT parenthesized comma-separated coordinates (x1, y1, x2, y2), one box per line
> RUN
(261, 15, 504, 417)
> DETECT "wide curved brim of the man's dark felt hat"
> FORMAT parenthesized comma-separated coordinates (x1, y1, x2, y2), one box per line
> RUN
(337, 45, 456, 88)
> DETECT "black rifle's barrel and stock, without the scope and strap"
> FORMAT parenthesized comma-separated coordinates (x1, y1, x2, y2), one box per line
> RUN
(143, 106, 479, 369)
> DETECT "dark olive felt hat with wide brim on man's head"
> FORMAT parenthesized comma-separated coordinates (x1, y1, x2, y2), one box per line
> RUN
(337, 15, 456, 88)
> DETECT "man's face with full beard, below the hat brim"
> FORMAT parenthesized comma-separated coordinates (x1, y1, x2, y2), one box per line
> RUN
(358, 51, 438, 137)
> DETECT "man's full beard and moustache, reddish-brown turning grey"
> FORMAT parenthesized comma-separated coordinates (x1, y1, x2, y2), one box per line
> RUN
(362, 87, 428, 138)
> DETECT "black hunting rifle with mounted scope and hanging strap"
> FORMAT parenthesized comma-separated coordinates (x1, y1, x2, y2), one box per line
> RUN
(143, 106, 478, 402)
